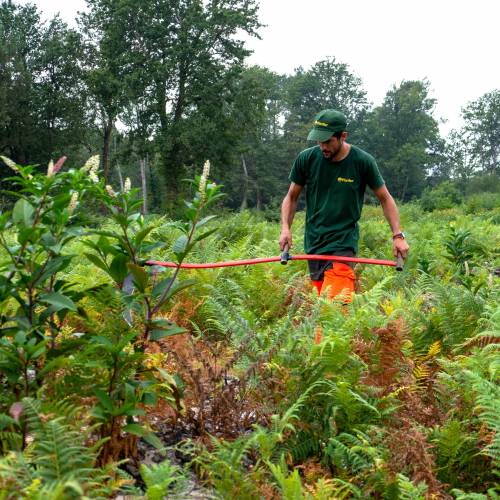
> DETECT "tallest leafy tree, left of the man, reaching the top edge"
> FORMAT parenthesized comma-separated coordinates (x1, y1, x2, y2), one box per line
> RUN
(127, 0, 259, 203)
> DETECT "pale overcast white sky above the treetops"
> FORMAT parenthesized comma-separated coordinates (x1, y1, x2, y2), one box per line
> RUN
(21, 0, 500, 133)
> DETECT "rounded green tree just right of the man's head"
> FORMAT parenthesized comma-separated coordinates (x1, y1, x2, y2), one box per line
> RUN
(362, 80, 442, 201)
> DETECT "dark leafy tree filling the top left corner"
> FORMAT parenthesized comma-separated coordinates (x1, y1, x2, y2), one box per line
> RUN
(0, 1, 86, 168)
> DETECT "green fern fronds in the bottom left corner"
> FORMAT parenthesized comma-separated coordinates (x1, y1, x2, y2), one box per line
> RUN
(0, 398, 129, 499)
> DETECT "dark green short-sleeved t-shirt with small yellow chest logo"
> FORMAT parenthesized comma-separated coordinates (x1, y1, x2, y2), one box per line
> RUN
(289, 145, 384, 255)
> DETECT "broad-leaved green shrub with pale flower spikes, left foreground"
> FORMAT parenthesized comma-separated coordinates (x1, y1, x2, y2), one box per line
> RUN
(0, 157, 220, 472)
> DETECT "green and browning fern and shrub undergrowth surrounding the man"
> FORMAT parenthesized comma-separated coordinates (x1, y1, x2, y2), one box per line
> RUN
(0, 155, 500, 499)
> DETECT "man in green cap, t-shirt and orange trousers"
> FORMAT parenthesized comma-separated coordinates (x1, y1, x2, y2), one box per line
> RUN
(279, 109, 409, 301)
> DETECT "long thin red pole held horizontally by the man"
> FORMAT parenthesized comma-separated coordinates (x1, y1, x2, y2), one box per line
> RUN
(145, 255, 396, 269)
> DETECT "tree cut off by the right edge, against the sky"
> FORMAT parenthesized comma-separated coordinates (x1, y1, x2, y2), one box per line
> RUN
(462, 90, 500, 174)
